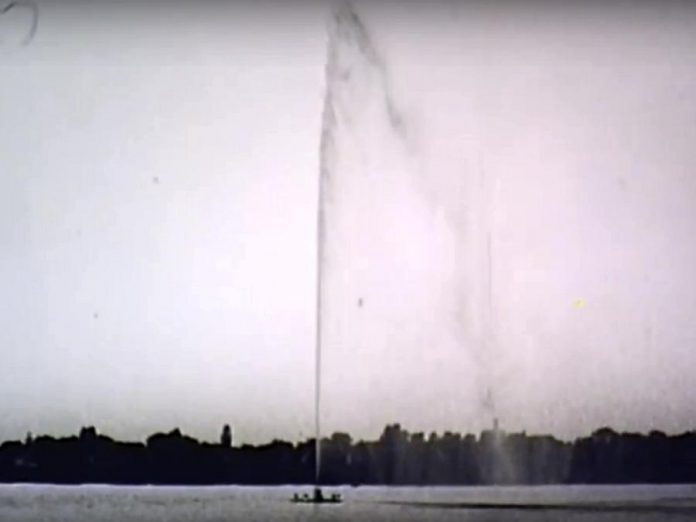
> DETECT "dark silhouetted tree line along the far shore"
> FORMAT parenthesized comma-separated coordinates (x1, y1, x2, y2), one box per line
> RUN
(0, 424, 696, 485)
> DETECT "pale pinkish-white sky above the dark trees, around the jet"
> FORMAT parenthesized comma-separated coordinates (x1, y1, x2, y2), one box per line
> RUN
(0, 2, 696, 442)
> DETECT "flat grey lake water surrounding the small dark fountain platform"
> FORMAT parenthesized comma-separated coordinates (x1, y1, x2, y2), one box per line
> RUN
(0, 485, 696, 522)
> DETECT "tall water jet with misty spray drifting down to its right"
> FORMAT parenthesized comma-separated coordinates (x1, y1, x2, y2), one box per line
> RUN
(316, 2, 500, 436)
